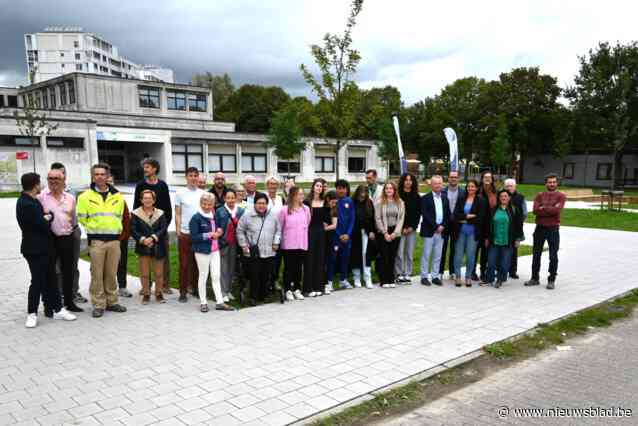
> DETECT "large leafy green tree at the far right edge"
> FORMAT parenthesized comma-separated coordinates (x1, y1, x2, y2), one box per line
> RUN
(567, 41, 638, 188)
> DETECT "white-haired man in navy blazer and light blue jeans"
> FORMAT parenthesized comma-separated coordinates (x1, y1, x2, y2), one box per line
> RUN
(421, 175, 450, 285)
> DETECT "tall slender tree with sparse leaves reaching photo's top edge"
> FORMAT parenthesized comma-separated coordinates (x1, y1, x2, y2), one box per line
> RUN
(300, 0, 363, 179)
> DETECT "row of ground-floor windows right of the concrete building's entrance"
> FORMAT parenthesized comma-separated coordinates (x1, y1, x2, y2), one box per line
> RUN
(172, 144, 366, 173)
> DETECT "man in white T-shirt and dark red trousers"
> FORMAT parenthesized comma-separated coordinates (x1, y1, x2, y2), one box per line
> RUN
(175, 167, 205, 303)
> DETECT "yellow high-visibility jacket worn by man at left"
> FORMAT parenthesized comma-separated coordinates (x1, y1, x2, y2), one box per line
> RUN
(76, 187, 125, 240)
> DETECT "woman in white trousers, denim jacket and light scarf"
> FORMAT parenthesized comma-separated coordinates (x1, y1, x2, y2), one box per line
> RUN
(188, 192, 235, 312)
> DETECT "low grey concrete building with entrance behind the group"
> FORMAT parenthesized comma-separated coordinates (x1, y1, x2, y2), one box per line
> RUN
(0, 72, 387, 188)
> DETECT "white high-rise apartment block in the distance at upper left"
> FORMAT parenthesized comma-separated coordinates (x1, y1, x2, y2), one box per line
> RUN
(24, 27, 174, 83)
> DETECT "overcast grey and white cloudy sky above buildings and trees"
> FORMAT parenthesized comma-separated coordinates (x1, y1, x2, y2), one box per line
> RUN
(0, 0, 638, 105)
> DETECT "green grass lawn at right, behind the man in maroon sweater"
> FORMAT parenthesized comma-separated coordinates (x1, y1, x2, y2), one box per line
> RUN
(527, 209, 638, 232)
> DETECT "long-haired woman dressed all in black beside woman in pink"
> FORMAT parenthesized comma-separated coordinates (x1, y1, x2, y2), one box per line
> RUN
(303, 179, 332, 297)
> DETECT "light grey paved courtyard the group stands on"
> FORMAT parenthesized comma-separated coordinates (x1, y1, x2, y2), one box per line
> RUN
(0, 200, 638, 426)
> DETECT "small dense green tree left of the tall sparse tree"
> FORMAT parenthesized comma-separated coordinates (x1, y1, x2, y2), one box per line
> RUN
(264, 102, 306, 175)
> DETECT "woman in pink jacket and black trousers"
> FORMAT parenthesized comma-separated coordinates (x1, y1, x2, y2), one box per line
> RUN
(279, 186, 311, 301)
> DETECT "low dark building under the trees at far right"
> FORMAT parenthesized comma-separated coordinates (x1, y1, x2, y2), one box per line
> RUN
(523, 151, 638, 188)
